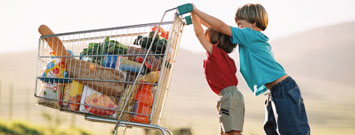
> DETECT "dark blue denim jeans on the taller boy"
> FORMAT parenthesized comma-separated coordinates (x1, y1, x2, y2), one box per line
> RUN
(264, 77, 310, 135)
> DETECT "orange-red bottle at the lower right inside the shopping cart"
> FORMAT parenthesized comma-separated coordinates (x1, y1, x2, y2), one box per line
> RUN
(131, 84, 154, 124)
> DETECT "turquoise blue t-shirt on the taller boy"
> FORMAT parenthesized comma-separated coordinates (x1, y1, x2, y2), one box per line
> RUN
(231, 27, 286, 96)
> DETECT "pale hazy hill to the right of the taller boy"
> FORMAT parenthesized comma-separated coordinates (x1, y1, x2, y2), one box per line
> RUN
(271, 22, 355, 84)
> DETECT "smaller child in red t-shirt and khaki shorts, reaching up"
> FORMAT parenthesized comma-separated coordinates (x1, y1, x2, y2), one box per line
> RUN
(191, 13, 245, 135)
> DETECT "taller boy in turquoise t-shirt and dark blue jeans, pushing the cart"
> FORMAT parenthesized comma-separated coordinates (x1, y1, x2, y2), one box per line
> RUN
(187, 4, 310, 135)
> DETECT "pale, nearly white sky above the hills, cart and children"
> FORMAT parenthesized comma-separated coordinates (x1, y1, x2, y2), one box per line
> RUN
(0, 0, 355, 54)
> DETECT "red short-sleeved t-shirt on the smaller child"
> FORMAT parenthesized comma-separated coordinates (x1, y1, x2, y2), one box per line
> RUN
(203, 45, 238, 95)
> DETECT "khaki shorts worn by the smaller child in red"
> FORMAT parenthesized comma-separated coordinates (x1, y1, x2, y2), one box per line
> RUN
(217, 86, 245, 133)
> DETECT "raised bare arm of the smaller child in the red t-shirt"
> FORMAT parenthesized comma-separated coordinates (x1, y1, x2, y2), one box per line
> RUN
(191, 13, 212, 53)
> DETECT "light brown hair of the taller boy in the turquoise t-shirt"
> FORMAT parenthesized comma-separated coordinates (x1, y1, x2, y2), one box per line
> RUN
(234, 4, 269, 31)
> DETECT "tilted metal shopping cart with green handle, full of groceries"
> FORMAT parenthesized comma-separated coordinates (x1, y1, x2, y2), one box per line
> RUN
(35, 4, 191, 135)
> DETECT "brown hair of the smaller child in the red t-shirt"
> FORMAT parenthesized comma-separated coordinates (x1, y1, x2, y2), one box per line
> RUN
(205, 28, 237, 53)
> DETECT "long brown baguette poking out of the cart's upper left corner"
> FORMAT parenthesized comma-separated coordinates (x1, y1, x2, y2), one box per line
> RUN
(39, 25, 124, 96)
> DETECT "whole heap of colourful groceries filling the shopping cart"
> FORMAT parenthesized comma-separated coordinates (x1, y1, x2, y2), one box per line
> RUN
(38, 26, 169, 123)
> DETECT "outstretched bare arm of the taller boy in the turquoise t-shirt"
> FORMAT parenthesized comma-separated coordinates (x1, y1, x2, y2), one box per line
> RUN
(191, 5, 232, 36)
